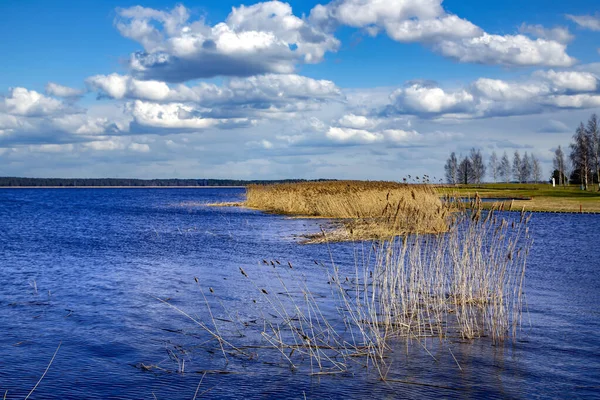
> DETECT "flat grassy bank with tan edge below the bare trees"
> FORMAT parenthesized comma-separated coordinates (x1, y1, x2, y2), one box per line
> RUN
(439, 183, 600, 212)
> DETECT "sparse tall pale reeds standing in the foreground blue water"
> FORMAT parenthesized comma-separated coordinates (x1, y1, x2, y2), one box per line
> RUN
(162, 198, 532, 380)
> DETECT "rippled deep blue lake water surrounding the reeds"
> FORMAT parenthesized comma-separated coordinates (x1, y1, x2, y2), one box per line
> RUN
(0, 189, 600, 399)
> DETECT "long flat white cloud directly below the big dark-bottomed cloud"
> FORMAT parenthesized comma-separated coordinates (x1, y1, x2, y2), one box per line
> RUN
(86, 74, 343, 125)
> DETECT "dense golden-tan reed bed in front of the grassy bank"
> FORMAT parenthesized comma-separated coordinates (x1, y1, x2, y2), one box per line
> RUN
(244, 181, 448, 240)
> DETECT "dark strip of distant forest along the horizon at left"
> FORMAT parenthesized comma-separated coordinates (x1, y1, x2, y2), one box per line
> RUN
(0, 177, 328, 187)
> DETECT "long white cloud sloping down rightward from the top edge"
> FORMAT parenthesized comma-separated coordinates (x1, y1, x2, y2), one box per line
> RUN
(309, 0, 575, 67)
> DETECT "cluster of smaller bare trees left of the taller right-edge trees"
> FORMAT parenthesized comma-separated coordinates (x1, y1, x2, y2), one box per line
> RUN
(444, 148, 542, 184)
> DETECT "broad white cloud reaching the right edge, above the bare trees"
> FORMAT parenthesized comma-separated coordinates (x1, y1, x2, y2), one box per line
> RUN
(378, 69, 600, 119)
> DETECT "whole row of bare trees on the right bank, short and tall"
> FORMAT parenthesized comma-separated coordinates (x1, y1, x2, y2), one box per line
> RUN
(444, 114, 600, 190)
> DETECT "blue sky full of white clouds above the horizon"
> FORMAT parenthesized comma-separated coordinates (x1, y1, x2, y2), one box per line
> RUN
(0, 0, 600, 180)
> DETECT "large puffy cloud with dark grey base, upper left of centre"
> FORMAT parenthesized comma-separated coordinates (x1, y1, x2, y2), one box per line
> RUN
(116, 1, 339, 82)
